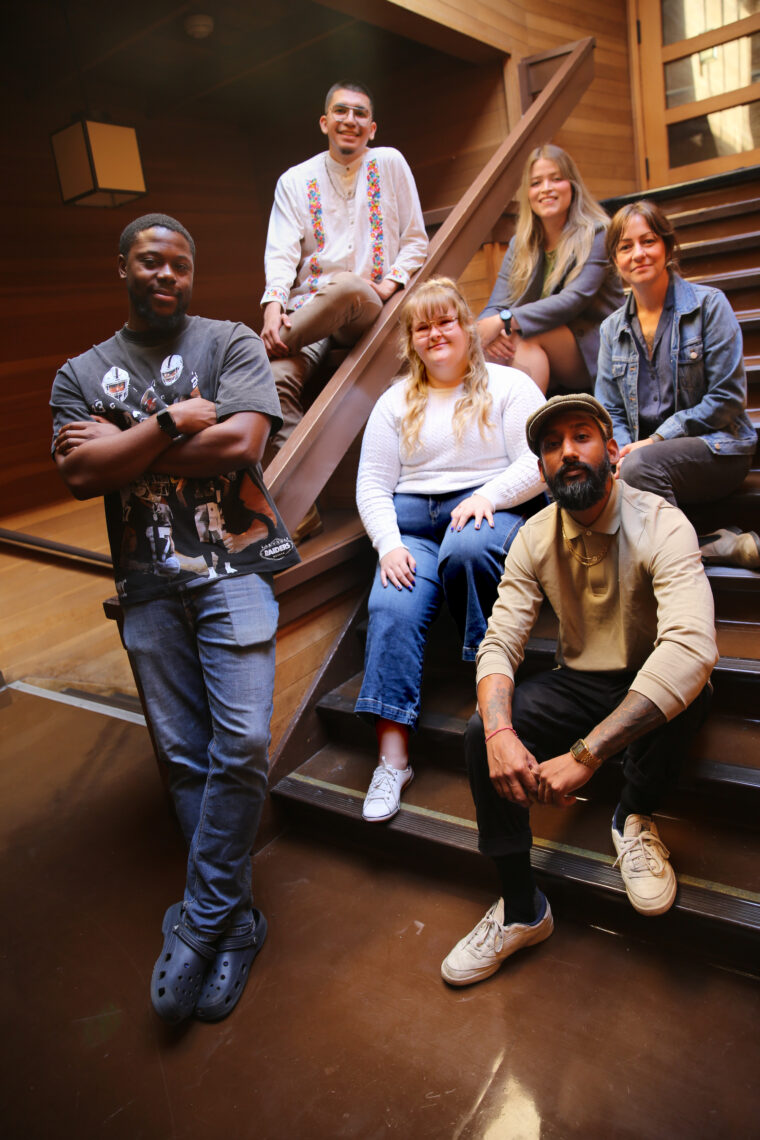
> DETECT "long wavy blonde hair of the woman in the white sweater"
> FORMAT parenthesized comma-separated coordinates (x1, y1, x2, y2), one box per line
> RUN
(401, 277, 493, 455)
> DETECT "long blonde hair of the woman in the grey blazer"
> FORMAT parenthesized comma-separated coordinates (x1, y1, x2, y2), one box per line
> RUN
(509, 143, 610, 304)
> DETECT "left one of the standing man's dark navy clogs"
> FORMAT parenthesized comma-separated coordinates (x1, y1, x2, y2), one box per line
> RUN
(150, 903, 216, 1025)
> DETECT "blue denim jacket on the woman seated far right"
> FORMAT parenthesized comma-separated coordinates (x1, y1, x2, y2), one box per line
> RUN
(595, 274, 757, 455)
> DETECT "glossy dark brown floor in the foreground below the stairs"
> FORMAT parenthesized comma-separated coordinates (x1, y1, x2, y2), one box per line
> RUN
(0, 690, 760, 1140)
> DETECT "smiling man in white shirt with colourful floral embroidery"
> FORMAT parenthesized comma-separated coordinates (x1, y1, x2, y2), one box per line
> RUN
(261, 82, 427, 537)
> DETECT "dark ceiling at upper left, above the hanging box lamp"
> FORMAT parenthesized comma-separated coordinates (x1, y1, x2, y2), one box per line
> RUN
(3, 0, 505, 136)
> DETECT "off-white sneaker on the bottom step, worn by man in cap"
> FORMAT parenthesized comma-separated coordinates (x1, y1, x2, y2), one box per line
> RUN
(612, 814, 678, 914)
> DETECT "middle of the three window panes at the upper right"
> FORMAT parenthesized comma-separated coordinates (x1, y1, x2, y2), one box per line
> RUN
(665, 33, 760, 107)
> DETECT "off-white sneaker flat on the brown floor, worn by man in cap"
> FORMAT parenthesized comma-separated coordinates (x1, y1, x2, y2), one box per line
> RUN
(441, 891, 554, 986)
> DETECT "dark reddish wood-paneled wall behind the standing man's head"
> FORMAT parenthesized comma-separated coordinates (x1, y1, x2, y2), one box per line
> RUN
(0, 105, 273, 514)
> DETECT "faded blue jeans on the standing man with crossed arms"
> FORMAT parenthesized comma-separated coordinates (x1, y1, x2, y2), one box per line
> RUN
(124, 573, 278, 948)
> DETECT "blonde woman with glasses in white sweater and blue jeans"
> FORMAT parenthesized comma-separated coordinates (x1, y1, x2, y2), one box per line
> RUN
(356, 277, 545, 822)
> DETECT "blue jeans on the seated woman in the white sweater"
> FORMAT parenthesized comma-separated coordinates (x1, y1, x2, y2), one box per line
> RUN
(356, 490, 545, 728)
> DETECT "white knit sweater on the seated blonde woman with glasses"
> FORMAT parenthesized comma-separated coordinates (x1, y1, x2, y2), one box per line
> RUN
(357, 364, 544, 559)
